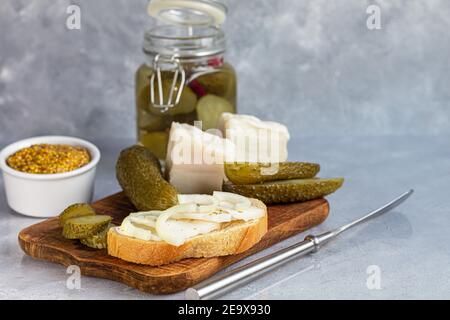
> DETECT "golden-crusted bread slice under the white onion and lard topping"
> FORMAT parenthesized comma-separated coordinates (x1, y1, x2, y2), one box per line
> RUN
(108, 199, 267, 266)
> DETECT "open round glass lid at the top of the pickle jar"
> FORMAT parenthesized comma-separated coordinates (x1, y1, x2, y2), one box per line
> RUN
(147, 0, 227, 26)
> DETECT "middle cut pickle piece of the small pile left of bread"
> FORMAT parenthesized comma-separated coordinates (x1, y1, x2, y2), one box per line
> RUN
(63, 215, 112, 239)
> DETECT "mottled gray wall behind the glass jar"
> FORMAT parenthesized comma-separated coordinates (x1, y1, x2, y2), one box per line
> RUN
(0, 0, 450, 142)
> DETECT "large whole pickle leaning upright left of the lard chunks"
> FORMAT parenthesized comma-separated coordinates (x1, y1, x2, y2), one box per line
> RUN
(116, 146, 178, 211)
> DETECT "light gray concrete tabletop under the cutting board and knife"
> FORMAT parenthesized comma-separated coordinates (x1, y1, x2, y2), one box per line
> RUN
(0, 136, 450, 299)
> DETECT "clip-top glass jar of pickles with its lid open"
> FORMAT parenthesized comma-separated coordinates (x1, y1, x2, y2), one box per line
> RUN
(136, 0, 237, 159)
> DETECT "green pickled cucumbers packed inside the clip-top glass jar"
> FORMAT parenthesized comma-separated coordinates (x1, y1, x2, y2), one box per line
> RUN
(136, 60, 236, 159)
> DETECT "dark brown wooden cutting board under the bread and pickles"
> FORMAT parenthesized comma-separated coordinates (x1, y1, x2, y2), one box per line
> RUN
(19, 193, 329, 294)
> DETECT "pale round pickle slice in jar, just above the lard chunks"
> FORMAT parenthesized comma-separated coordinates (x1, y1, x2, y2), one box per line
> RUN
(197, 94, 234, 131)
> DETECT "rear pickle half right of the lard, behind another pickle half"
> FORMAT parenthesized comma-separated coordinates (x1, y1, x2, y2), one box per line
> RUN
(225, 162, 320, 184)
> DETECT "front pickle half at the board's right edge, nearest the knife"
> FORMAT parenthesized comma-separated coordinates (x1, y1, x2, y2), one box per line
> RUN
(223, 178, 344, 204)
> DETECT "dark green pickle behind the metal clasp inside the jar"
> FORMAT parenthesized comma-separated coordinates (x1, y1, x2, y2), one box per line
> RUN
(149, 75, 197, 116)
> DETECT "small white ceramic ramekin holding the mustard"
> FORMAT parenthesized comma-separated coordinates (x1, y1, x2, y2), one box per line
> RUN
(0, 136, 100, 218)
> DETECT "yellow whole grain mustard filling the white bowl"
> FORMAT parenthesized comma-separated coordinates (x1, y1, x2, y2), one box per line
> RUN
(6, 144, 91, 174)
